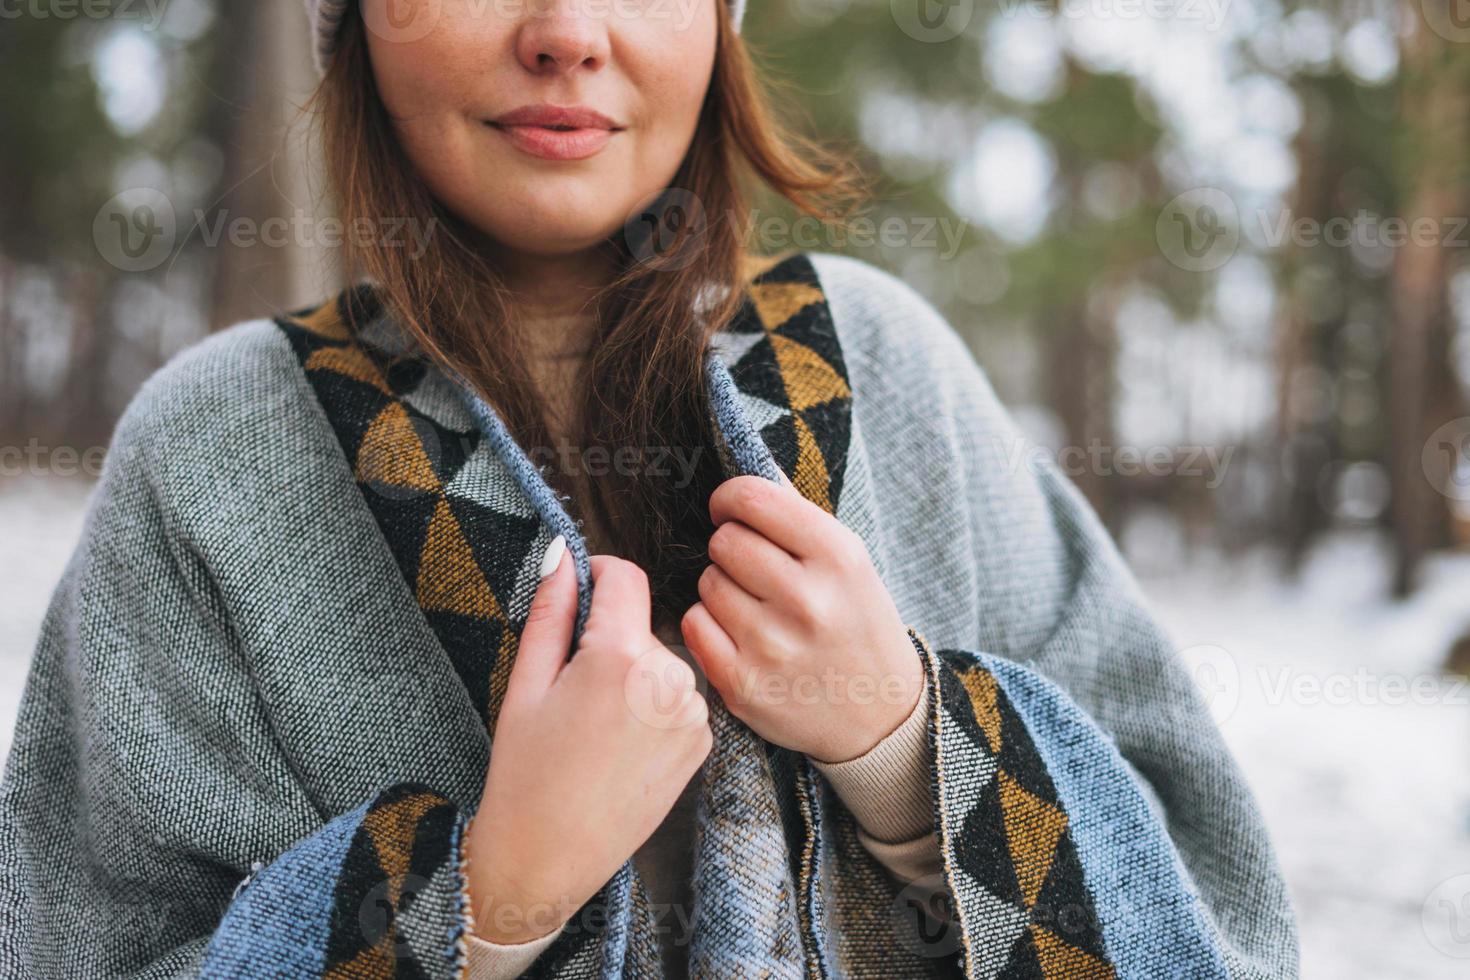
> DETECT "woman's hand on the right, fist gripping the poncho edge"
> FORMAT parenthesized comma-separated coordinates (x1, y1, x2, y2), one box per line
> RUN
(681, 476, 923, 763)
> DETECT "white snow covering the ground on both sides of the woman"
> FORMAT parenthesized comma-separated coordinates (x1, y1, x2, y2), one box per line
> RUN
(0, 478, 1470, 980)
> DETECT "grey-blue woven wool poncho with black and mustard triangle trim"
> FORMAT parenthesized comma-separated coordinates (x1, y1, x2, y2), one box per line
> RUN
(0, 253, 1298, 980)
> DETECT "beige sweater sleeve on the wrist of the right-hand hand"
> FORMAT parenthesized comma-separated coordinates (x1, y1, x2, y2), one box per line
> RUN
(811, 674, 948, 920)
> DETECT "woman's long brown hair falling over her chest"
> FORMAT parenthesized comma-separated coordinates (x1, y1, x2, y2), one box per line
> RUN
(309, 0, 866, 621)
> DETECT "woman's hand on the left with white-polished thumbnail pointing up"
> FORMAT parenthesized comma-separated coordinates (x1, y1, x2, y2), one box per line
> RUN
(465, 542, 713, 943)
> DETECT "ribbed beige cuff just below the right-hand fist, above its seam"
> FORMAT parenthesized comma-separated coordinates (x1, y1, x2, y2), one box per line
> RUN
(811, 671, 933, 843)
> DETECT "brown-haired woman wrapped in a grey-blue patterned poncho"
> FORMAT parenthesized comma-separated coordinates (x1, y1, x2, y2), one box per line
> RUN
(0, 0, 1297, 979)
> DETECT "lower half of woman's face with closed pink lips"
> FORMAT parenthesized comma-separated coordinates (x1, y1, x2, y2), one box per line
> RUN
(362, 0, 723, 256)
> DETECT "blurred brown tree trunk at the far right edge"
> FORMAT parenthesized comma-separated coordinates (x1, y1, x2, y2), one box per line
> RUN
(1389, 1, 1470, 597)
